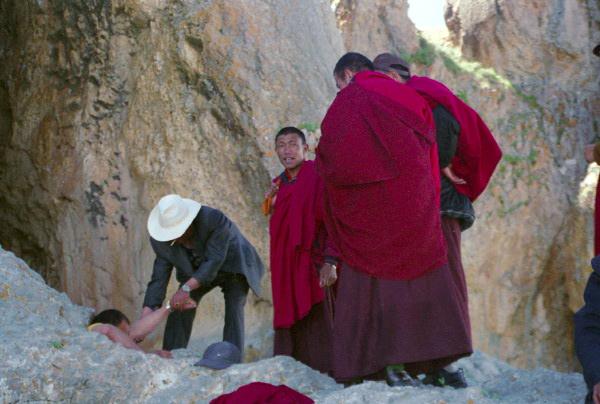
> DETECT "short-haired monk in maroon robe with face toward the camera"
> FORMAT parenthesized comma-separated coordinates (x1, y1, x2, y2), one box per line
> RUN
(263, 127, 337, 372)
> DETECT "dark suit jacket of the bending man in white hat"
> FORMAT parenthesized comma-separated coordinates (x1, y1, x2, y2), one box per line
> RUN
(144, 206, 264, 308)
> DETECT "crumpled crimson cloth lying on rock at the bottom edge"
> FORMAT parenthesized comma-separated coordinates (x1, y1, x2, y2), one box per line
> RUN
(210, 382, 314, 404)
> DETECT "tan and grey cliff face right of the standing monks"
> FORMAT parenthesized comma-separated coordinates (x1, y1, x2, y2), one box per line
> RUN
(446, 0, 600, 369)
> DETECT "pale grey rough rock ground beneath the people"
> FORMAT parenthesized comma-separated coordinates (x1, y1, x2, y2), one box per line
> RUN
(0, 248, 585, 404)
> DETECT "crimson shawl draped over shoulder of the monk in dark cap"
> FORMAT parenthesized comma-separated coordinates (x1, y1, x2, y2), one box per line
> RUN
(406, 76, 502, 201)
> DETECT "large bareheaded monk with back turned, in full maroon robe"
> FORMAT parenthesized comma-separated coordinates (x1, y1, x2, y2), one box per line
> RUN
(316, 53, 471, 385)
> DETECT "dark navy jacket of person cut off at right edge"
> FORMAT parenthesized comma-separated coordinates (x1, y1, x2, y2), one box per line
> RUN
(575, 255, 600, 390)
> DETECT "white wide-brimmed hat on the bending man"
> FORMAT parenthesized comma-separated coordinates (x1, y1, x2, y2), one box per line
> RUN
(148, 194, 202, 241)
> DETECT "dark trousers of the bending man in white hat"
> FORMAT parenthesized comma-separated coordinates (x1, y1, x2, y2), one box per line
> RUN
(163, 272, 249, 352)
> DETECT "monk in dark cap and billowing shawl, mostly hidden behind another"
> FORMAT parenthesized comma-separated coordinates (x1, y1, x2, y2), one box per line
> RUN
(373, 53, 502, 387)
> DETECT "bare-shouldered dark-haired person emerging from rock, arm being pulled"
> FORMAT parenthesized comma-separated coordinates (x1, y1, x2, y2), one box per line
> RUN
(87, 301, 191, 358)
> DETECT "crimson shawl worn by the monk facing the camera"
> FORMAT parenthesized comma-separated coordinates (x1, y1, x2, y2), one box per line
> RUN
(269, 161, 325, 328)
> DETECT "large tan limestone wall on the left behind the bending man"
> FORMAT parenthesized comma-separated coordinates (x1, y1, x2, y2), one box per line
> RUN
(0, 0, 342, 348)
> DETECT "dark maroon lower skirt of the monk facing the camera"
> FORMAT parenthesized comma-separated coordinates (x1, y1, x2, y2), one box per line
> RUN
(273, 296, 333, 373)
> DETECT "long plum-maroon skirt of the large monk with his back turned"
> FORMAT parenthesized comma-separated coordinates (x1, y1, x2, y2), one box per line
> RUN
(331, 219, 473, 381)
